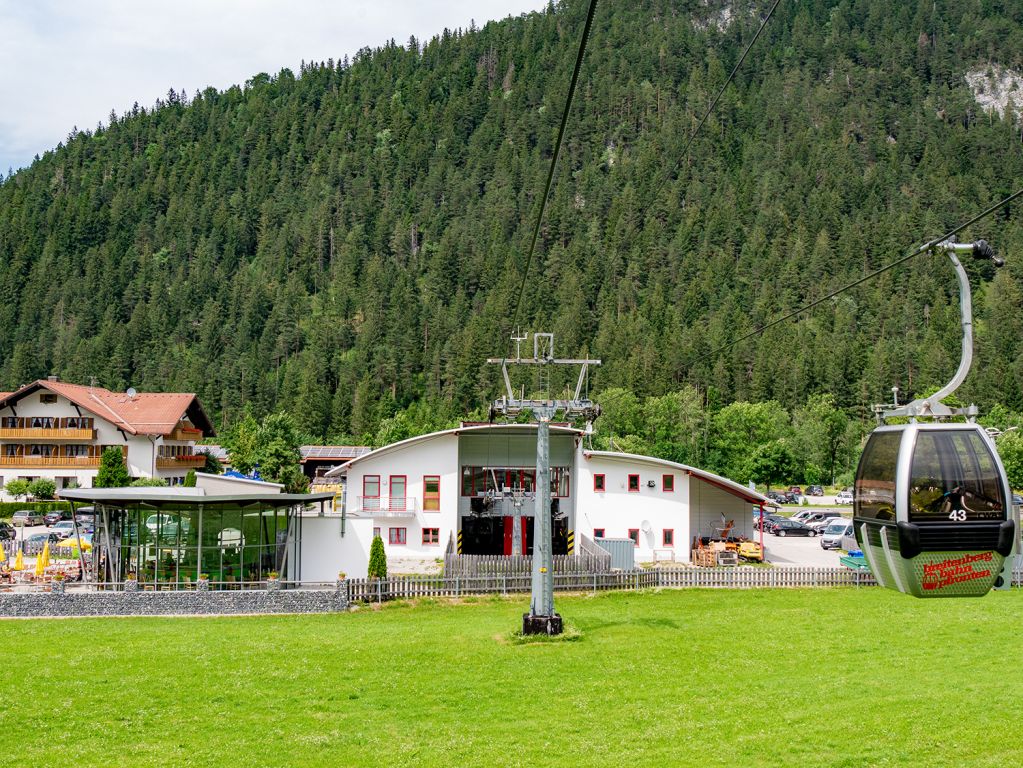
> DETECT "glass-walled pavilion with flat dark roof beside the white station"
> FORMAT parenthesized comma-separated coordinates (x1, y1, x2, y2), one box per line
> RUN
(60, 488, 333, 589)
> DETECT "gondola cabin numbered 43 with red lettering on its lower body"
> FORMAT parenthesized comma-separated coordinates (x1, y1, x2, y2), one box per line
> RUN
(853, 422, 1016, 597)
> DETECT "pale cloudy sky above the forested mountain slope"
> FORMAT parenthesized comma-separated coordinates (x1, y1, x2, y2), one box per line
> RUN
(0, 0, 547, 174)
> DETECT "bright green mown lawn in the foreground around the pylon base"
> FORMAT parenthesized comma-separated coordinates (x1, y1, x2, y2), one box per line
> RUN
(0, 589, 1023, 768)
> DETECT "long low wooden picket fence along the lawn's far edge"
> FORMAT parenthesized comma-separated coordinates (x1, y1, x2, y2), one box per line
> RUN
(348, 558, 877, 602)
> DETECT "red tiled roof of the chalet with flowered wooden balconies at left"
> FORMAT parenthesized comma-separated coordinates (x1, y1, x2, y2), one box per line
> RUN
(0, 379, 214, 437)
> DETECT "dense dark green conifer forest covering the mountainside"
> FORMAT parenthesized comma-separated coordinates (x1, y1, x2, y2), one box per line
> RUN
(0, 0, 1023, 473)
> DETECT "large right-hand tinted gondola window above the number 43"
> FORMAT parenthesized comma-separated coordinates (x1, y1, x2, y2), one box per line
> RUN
(909, 430, 1005, 523)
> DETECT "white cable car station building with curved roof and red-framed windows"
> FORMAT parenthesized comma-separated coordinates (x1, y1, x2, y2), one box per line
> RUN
(321, 423, 767, 573)
